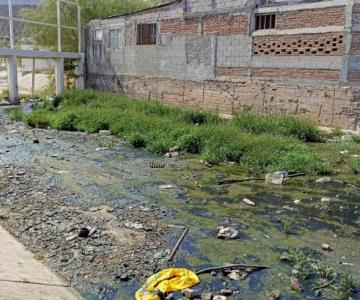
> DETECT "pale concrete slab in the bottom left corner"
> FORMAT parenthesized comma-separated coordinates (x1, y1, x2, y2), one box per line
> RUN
(0, 226, 81, 300)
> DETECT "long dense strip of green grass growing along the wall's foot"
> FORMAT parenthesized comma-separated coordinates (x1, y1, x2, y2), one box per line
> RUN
(19, 90, 329, 174)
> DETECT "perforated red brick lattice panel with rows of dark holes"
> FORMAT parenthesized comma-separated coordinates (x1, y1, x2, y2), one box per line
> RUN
(253, 33, 344, 56)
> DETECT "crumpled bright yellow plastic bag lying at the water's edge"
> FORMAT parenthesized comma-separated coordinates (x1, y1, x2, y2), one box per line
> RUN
(135, 269, 200, 300)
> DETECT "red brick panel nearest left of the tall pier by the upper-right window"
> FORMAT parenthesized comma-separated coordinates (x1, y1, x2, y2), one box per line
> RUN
(203, 14, 249, 35)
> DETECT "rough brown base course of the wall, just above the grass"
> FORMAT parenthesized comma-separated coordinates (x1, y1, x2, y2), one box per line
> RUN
(87, 74, 360, 130)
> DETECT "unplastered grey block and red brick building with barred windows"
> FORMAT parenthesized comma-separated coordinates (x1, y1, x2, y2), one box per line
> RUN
(86, 0, 360, 130)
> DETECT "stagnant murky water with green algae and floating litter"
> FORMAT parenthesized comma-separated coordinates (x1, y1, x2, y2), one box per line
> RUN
(0, 106, 360, 299)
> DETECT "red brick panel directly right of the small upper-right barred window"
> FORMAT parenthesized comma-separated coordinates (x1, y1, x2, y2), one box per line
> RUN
(276, 6, 346, 29)
